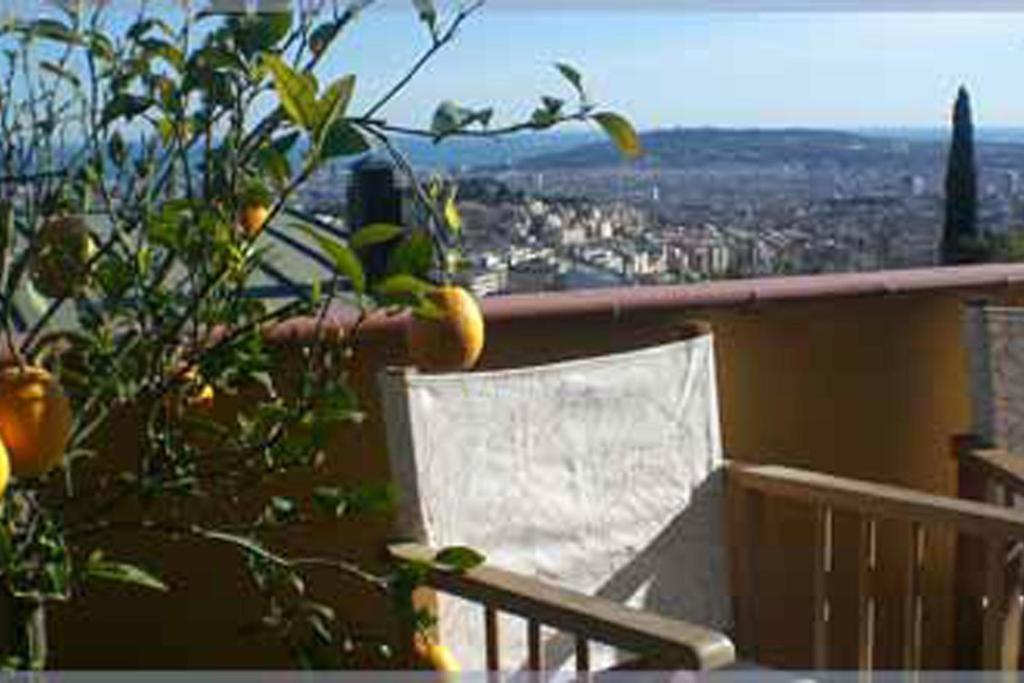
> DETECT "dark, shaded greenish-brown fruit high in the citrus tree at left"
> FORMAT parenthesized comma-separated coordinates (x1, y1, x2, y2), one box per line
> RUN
(31, 216, 96, 299)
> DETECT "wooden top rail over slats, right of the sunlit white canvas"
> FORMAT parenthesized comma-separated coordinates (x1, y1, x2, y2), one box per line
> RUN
(727, 462, 1024, 540)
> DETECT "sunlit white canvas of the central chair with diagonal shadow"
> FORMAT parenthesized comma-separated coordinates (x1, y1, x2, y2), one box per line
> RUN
(381, 334, 731, 670)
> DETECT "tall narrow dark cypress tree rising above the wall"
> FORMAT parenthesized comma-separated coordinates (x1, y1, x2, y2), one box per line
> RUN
(941, 86, 985, 265)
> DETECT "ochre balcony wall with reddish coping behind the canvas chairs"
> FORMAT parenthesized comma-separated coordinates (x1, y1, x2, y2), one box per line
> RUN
(51, 266, 1024, 669)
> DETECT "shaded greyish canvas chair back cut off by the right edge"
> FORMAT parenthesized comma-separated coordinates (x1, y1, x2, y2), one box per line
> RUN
(966, 304, 1024, 456)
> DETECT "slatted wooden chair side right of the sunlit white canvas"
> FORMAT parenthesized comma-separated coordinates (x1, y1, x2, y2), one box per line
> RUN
(728, 463, 1024, 670)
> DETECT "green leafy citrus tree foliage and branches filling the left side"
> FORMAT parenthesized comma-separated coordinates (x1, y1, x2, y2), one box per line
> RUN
(0, 0, 639, 666)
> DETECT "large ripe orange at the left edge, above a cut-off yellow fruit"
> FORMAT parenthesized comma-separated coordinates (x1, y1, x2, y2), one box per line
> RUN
(0, 366, 72, 477)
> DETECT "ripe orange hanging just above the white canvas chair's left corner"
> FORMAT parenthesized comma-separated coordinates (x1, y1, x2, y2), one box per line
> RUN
(406, 286, 483, 371)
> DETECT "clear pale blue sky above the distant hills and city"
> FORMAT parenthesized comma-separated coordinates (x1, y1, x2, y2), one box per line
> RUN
(16, 0, 1024, 129)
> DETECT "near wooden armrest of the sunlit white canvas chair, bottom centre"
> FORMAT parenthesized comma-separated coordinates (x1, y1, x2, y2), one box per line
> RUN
(388, 544, 735, 670)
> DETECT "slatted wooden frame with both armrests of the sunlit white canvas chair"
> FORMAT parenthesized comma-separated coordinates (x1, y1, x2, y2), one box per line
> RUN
(390, 450, 1024, 671)
